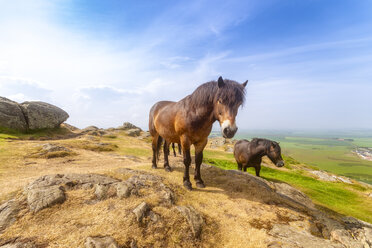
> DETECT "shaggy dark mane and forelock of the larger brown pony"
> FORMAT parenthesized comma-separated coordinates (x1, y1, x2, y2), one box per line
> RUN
(189, 79, 245, 107)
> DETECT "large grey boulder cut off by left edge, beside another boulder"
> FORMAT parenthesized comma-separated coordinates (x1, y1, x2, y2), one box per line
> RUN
(0, 97, 27, 131)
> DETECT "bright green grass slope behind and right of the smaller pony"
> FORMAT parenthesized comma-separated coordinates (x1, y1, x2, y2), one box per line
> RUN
(204, 157, 372, 223)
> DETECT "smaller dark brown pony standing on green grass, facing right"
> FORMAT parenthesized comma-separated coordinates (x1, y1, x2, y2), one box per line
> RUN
(234, 138, 284, 177)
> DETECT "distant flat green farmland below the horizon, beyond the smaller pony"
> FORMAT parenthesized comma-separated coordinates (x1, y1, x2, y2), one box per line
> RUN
(235, 132, 372, 184)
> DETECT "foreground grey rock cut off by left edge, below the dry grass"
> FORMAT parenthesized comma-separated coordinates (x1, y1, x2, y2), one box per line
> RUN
(0, 200, 22, 232)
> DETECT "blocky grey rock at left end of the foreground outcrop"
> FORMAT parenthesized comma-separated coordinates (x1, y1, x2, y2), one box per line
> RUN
(27, 185, 66, 212)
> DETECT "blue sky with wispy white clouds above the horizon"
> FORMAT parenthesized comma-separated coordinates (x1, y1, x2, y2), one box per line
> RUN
(0, 0, 372, 129)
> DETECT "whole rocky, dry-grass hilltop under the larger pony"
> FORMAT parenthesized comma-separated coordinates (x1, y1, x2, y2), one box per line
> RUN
(0, 124, 372, 248)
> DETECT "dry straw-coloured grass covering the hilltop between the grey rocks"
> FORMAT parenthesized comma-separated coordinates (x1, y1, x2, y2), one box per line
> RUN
(0, 132, 314, 247)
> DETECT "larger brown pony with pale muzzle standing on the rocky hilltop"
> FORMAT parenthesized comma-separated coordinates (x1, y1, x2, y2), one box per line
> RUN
(149, 77, 248, 190)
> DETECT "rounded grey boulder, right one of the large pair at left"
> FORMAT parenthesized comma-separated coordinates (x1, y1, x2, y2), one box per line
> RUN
(20, 102, 69, 130)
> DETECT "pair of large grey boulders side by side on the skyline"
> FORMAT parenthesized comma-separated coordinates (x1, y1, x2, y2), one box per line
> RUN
(0, 97, 69, 131)
